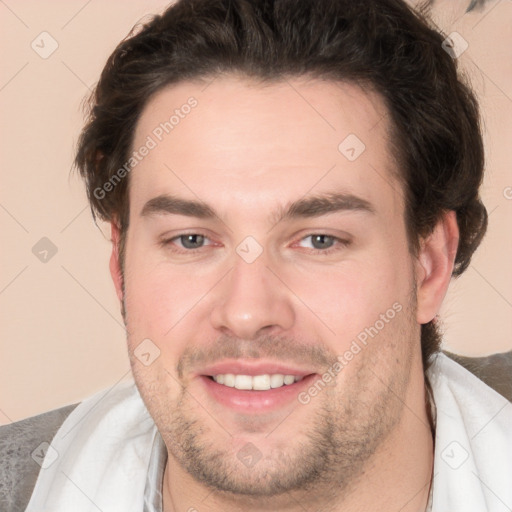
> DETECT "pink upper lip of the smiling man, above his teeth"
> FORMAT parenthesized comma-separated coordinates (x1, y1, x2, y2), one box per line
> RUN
(196, 360, 315, 377)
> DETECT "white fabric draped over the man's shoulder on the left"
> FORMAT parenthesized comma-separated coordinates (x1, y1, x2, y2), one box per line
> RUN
(26, 380, 157, 512)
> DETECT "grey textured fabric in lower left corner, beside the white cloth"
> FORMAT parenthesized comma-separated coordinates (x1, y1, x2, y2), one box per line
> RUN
(0, 404, 78, 512)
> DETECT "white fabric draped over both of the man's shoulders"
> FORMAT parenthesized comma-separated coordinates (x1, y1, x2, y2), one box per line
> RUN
(26, 354, 512, 512)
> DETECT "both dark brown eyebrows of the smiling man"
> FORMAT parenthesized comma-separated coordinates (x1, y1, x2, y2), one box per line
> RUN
(141, 193, 376, 224)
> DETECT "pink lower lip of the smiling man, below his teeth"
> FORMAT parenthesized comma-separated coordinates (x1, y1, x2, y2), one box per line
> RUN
(200, 374, 316, 413)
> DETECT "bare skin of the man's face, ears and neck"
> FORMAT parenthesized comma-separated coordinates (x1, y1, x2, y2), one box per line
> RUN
(111, 75, 458, 512)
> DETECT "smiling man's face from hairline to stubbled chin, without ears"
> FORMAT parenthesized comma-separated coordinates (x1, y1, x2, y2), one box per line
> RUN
(119, 77, 423, 496)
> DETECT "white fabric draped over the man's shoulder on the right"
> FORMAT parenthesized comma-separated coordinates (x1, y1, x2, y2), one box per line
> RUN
(429, 354, 512, 512)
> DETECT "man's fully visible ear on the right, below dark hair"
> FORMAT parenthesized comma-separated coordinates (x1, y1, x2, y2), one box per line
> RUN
(416, 210, 459, 324)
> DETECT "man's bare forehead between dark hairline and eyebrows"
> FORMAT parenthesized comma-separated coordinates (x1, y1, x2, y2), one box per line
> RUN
(130, 76, 401, 220)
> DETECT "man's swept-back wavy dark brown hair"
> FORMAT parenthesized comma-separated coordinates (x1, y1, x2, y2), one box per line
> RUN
(75, 0, 487, 369)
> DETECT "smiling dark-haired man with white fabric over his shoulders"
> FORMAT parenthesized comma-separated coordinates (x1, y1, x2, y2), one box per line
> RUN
(1, 0, 512, 512)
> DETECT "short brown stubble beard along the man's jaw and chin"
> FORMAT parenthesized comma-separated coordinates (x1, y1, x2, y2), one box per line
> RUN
(127, 309, 414, 499)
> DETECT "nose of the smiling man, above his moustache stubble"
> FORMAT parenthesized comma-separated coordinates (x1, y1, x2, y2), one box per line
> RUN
(211, 253, 295, 340)
